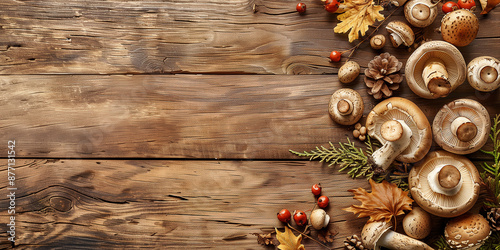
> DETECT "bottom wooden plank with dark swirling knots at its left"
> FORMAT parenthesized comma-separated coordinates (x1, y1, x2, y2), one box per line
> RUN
(0, 159, 376, 249)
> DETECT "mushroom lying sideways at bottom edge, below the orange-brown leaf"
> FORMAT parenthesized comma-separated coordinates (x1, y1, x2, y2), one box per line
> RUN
(361, 221, 433, 250)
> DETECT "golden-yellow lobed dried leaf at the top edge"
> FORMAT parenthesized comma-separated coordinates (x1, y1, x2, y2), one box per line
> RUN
(333, 0, 384, 42)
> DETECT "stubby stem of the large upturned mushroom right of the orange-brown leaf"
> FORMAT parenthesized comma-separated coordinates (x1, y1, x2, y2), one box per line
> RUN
(427, 164, 463, 196)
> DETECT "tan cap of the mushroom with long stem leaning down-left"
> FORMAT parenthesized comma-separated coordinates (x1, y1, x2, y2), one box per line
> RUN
(366, 97, 432, 163)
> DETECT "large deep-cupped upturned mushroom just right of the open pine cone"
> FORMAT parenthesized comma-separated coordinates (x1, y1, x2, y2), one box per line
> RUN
(405, 41, 466, 99)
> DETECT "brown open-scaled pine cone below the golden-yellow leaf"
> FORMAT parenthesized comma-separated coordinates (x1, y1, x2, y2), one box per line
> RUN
(365, 52, 403, 99)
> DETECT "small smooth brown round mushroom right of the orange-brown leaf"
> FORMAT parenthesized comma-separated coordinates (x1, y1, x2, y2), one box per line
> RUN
(403, 207, 432, 240)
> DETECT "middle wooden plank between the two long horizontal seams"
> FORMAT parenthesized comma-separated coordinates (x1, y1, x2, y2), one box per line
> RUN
(0, 75, 500, 159)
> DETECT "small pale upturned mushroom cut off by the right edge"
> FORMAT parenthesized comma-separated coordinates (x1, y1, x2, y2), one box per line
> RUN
(467, 56, 500, 92)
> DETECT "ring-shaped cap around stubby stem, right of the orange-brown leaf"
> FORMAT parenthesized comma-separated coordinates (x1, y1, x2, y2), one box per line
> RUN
(408, 150, 481, 218)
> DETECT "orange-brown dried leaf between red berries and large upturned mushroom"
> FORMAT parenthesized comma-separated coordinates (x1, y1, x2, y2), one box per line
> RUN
(344, 179, 413, 222)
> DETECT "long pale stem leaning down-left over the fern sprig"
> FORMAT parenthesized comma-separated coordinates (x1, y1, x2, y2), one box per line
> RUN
(372, 120, 412, 170)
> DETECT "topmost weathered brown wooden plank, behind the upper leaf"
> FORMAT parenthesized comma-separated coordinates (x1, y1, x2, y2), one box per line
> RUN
(0, 0, 500, 74)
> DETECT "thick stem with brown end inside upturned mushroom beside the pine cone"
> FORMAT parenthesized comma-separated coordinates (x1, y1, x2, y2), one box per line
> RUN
(422, 58, 451, 97)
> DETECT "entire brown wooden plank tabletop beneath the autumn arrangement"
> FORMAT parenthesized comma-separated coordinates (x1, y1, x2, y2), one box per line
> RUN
(0, 0, 500, 249)
